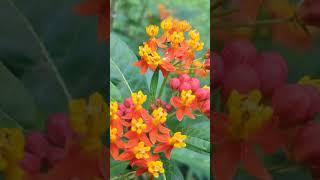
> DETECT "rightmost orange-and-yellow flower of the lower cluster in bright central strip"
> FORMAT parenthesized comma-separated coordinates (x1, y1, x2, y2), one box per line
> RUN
(154, 132, 187, 159)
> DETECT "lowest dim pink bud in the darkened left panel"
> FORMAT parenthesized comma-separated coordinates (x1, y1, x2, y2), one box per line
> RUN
(21, 152, 41, 173)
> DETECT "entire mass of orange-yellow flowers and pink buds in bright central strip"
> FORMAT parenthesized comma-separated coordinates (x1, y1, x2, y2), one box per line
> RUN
(110, 16, 210, 178)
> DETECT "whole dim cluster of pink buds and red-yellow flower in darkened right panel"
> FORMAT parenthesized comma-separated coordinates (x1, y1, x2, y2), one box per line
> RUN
(213, 40, 320, 179)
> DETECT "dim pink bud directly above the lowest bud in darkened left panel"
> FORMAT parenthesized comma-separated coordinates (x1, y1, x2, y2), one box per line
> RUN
(25, 132, 49, 159)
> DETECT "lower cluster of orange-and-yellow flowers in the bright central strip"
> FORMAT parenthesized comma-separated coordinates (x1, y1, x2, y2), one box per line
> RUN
(110, 91, 187, 177)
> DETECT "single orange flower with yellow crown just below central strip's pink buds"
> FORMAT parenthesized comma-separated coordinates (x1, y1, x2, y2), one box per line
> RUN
(170, 90, 196, 121)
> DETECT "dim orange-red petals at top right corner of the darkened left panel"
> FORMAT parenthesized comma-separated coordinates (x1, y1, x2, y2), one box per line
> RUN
(75, 0, 110, 41)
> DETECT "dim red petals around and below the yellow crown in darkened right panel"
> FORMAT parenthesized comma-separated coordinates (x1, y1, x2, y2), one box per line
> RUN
(212, 114, 283, 180)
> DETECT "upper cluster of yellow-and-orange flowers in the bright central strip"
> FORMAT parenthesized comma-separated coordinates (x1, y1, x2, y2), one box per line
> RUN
(135, 17, 209, 76)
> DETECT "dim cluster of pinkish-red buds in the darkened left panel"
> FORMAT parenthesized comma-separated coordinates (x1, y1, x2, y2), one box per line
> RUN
(21, 113, 73, 174)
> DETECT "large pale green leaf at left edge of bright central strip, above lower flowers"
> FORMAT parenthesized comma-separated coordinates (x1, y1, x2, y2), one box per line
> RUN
(110, 33, 149, 98)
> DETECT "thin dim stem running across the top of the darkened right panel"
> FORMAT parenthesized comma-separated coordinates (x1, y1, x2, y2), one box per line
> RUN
(215, 17, 294, 29)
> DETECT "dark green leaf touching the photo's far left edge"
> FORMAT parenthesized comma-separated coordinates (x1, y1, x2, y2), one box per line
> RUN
(0, 62, 42, 129)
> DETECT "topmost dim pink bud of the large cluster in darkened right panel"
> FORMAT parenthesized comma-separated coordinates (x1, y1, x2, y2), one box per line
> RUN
(221, 40, 257, 69)
